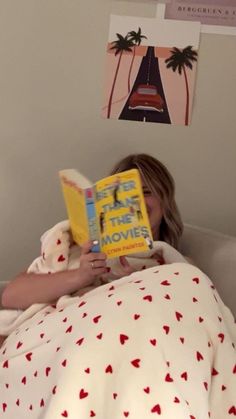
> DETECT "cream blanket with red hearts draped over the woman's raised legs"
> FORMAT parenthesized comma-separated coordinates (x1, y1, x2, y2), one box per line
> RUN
(0, 263, 236, 419)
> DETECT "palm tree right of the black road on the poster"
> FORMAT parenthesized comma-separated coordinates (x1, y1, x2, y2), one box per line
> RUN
(165, 45, 198, 125)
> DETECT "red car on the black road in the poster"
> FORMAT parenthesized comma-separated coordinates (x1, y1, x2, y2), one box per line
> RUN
(129, 84, 164, 112)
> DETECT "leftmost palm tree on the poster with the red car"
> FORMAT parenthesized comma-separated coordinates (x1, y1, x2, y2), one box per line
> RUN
(107, 33, 134, 118)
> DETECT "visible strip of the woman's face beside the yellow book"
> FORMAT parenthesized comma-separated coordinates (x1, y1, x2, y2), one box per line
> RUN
(142, 181, 163, 240)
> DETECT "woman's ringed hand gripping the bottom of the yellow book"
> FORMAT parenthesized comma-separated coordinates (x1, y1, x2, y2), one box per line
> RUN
(78, 241, 107, 286)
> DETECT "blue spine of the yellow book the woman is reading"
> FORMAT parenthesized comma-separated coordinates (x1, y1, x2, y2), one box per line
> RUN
(85, 188, 100, 252)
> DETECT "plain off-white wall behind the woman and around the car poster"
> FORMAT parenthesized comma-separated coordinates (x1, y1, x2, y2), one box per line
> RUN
(0, 0, 236, 281)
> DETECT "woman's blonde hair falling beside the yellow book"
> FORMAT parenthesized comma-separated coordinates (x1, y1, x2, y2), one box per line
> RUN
(110, 154, 183, 249)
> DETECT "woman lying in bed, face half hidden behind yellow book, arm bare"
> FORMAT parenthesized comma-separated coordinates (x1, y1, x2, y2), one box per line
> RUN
(2, 154, 186, 309)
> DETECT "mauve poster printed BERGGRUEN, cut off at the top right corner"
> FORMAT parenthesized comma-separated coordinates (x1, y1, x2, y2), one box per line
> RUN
(165, 0, 236, 35)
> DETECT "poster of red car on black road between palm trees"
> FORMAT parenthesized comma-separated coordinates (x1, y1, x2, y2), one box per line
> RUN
(102, 15, 200, 125)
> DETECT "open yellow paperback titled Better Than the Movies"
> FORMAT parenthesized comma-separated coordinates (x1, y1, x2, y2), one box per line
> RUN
(59, 169, 153, 258)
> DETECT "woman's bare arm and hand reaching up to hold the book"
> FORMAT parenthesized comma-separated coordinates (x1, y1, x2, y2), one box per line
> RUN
(2, 242, 107, 310)
